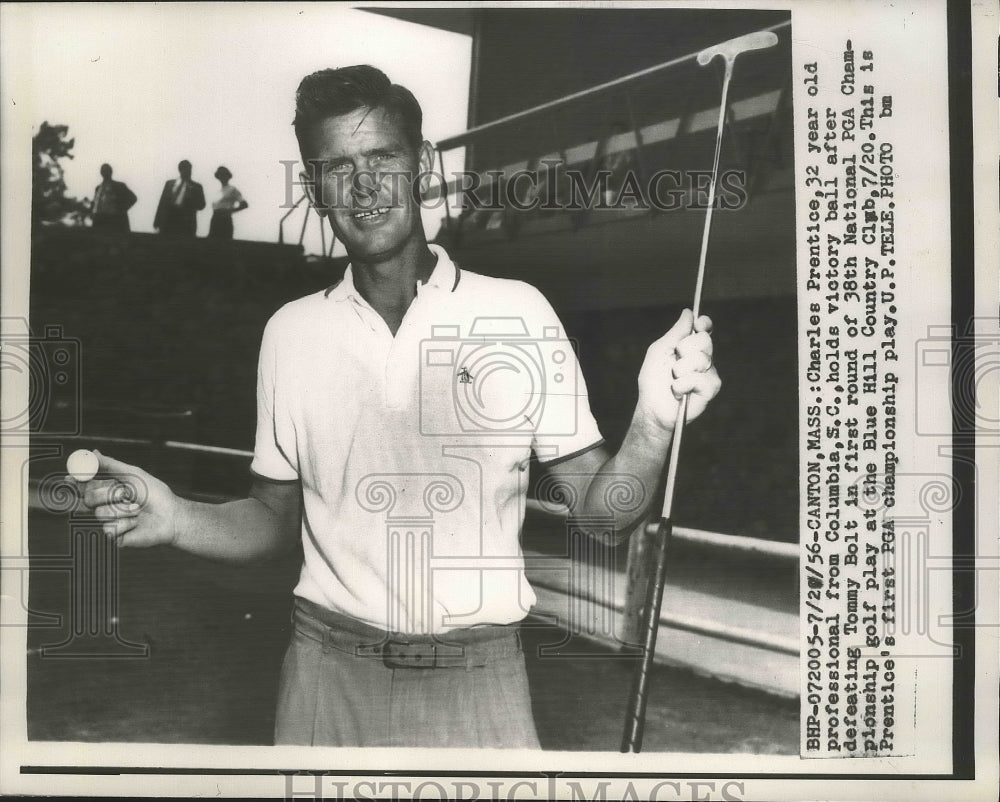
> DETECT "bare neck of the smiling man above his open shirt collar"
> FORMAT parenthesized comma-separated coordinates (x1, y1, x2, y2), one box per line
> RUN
(351, 241, 437, 334)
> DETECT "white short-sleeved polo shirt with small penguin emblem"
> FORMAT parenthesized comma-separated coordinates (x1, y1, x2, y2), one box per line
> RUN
(251, 245, 603, 633)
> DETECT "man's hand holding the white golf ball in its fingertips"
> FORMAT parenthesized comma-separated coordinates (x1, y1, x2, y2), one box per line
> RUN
(75, 451, 183, 547)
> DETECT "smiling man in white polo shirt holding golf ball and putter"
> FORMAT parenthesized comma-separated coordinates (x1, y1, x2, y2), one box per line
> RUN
(76, 66, 720, 748)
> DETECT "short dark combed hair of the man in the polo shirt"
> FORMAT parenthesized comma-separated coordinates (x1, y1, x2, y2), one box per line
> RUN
(292, 64, 424, 151)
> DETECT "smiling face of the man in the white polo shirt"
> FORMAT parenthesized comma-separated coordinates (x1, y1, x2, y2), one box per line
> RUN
(303, 108, 432, 262)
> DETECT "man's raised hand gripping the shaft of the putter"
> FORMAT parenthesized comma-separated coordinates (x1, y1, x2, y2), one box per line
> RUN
(638, 309, 722, 432)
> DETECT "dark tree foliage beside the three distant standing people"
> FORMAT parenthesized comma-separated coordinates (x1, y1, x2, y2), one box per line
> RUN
(31, 122, 89, 227)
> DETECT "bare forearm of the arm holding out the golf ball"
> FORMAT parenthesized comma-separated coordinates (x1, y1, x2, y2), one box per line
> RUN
(174, 497, 298, 563)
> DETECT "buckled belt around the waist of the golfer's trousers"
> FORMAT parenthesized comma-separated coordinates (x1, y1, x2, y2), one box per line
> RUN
(292, 599, 521, 671)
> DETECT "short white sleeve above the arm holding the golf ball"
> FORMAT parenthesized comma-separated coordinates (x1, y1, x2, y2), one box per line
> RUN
(250, 318, 299, 482)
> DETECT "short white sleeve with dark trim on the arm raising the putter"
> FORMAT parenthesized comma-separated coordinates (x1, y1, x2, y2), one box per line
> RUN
(526, 285, 604, 463)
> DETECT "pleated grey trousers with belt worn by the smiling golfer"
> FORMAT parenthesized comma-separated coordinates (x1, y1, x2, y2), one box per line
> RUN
(274, 599, 540, 749)
